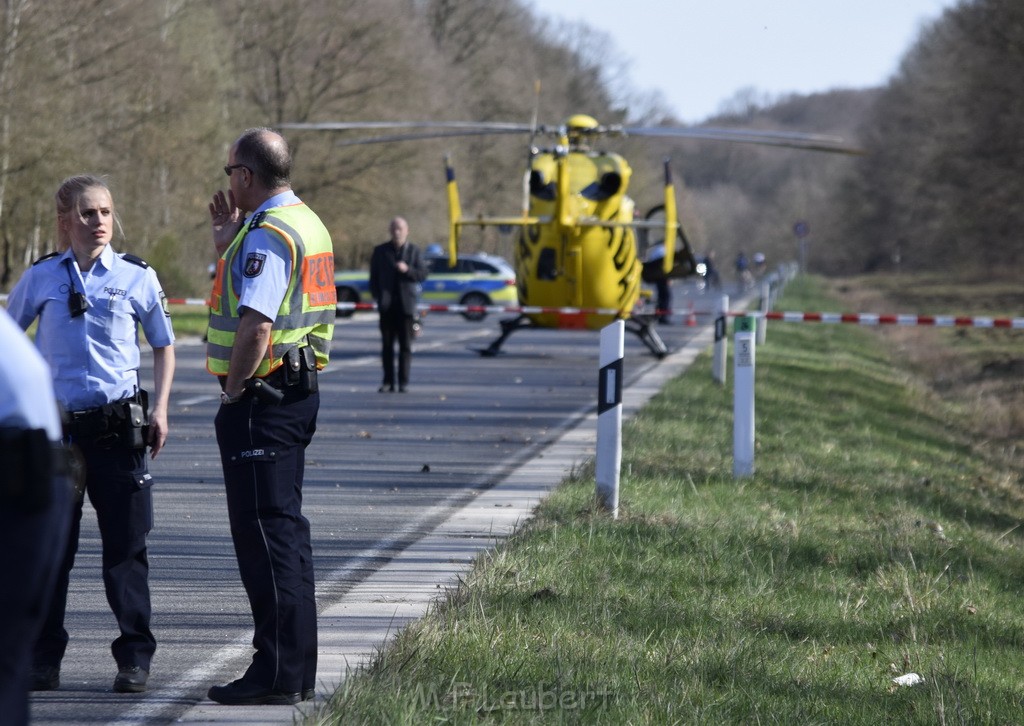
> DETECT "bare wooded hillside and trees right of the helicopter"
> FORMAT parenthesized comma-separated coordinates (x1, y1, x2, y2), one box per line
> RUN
(682, 0, 1024, 275)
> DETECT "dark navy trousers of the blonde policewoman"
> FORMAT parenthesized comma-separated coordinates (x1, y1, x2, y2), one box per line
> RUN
(33, 440, 157, 671)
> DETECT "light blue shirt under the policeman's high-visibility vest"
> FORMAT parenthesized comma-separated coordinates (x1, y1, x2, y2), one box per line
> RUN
(231, 191, 302, 321)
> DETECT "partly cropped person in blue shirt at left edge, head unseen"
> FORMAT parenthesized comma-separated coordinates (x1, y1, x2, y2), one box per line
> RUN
(0, 308, 72, 724)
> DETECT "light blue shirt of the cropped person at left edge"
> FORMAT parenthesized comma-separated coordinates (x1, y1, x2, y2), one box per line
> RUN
(0, 307, 60, 441)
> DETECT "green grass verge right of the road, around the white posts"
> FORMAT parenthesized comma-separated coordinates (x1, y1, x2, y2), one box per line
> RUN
(308, 279, 1024, 725)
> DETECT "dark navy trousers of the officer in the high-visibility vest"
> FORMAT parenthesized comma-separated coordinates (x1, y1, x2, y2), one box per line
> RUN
(214, 386, 319, 693)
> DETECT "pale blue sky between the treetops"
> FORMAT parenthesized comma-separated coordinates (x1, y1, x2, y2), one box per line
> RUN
(531, 0, 957, 123)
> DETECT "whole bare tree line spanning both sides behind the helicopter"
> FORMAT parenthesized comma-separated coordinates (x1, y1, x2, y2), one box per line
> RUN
(0, 0, 1024, 296)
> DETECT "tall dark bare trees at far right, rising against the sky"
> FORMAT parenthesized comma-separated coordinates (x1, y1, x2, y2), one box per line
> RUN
(839, 0, 1024, 269)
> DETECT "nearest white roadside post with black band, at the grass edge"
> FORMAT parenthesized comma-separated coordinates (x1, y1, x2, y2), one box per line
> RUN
(595, 321, 626, 519)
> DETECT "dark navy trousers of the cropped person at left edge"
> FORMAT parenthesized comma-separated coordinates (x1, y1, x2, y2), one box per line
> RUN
(0, 475, 73, 724)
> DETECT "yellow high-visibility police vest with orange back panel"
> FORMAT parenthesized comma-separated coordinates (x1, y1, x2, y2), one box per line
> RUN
(206, 203, 338, 378)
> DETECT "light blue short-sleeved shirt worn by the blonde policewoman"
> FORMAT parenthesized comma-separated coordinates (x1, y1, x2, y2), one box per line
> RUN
(7, 245, 174, 411)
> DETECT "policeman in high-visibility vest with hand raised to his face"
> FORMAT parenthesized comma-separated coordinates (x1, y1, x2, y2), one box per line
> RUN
(207, 129, 336, 704)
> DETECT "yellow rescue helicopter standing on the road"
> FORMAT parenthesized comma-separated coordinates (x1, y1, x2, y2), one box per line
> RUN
(280, 114, 857, 357)
